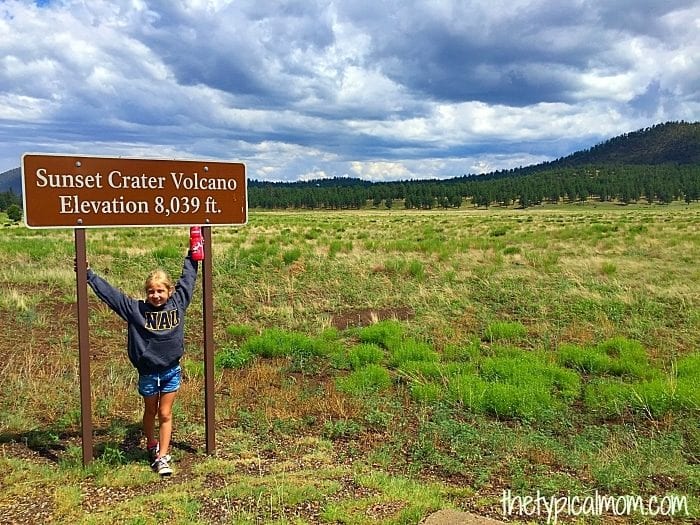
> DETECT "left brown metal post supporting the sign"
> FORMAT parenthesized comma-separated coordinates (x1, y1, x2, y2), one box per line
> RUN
(75, 228, 92, 465)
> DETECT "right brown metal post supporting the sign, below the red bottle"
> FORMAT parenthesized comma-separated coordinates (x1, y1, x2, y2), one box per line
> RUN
(202, 226, 216, 454)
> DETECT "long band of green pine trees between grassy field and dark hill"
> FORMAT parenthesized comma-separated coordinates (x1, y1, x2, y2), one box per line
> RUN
(248, 165, 700, 210)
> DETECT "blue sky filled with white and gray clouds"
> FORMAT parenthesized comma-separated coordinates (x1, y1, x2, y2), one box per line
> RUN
(0, 0, 700, 181)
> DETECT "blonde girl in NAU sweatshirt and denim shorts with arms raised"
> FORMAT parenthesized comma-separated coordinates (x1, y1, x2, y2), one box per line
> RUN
(87, 247, 198, 476)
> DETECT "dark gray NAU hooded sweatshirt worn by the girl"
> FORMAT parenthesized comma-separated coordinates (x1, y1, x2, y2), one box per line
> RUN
(87, 255, 198, 374)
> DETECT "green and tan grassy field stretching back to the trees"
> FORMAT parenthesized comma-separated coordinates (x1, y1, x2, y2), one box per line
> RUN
(0, 204, 700, 524)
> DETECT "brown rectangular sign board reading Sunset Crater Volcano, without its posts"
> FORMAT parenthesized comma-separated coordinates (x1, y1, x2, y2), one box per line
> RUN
(22, 153, 248, 228)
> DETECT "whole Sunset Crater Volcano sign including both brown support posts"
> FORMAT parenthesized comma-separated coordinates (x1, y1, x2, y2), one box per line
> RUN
(22, 153, 248, 465)
